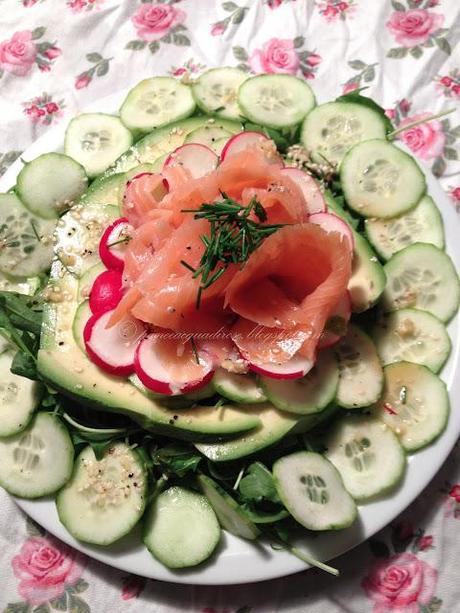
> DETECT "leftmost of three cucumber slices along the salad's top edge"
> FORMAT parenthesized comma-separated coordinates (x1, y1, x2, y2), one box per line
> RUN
(120, 77, 195, 134)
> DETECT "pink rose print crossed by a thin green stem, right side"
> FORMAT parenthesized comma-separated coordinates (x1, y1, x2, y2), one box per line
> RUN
(398, 113, 446, 160)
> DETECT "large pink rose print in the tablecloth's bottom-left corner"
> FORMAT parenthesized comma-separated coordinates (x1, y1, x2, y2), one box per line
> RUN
(11, 536, 84, 606)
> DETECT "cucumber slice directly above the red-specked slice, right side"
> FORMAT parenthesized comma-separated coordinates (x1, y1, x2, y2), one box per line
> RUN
(373, 309, 452, 372)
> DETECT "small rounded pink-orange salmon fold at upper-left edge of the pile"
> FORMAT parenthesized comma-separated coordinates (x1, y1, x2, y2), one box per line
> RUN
(122, 172, 169, 227)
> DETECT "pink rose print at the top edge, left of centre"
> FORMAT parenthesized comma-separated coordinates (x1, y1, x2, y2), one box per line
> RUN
(132, 2, 186, 42)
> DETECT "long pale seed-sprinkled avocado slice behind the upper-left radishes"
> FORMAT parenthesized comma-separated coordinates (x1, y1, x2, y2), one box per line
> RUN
(102, 115, 243, 176)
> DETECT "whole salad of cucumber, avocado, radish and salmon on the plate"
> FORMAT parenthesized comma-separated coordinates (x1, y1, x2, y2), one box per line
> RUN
(0, 68, 460, 573)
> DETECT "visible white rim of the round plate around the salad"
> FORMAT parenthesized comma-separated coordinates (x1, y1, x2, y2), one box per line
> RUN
(0, 92, 460, 585)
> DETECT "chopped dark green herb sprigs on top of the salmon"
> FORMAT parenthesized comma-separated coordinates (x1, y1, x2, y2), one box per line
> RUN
(181, 192, 284, 309)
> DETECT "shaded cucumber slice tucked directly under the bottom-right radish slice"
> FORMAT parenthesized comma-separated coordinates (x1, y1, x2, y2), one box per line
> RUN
(260, 351, 339, 415)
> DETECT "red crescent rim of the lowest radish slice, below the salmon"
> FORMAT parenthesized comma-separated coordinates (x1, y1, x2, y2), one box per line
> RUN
(134, 335, 214, 396)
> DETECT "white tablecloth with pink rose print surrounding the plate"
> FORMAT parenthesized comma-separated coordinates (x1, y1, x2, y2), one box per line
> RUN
(0, 0, 460, 613)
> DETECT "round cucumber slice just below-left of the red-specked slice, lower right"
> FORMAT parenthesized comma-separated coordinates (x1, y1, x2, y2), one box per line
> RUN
(324, 415, 406, 502)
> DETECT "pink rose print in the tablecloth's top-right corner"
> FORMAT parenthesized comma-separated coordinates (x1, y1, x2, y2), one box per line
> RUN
(386, 9, 444, 47)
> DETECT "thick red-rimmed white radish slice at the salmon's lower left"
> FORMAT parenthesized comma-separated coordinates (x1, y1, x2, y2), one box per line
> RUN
(83, 310, 145, 377)
